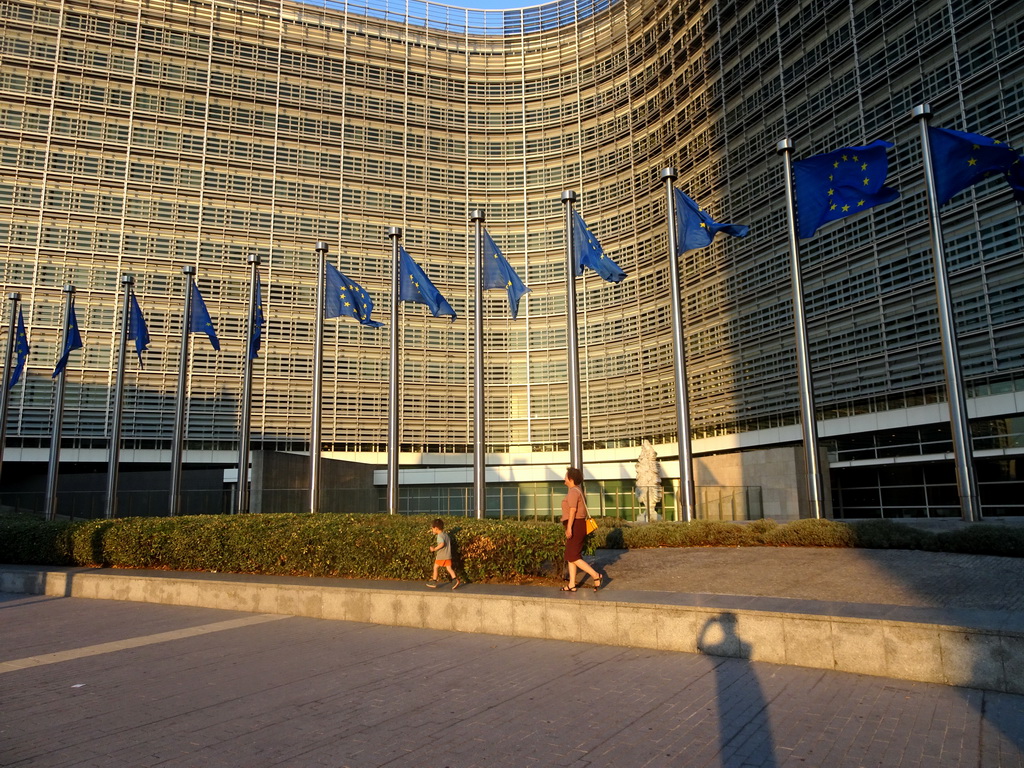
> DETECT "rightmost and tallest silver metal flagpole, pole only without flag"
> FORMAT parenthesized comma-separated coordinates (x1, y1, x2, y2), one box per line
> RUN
(910, 104, 981, 522)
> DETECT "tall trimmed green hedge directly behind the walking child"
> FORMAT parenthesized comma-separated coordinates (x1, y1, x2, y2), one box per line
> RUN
(0, 514, 564, 582)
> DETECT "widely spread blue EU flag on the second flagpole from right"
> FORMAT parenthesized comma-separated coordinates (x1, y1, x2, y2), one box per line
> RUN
(793, 141, 899, 239)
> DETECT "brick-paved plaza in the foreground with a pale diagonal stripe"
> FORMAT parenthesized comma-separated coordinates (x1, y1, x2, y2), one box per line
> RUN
(0, 594, 1024, 768)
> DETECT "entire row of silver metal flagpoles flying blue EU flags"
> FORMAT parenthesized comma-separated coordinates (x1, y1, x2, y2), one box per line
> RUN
(0, 104, 1024, 520)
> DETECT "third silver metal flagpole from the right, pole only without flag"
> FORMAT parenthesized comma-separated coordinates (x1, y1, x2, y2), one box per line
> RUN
(663, 168, 697, 522)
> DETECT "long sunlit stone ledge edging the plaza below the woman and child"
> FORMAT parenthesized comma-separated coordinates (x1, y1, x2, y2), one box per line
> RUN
(0, 565, 1024, 693)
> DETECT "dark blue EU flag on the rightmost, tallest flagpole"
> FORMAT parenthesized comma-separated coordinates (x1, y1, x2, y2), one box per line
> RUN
(928, 126, 1017, 206)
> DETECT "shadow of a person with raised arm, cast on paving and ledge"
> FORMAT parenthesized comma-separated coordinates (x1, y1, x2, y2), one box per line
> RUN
(697, 611, 777, 768)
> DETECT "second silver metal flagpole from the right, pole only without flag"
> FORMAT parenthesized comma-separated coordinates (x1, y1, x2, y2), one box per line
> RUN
(776, 138, 824, 518)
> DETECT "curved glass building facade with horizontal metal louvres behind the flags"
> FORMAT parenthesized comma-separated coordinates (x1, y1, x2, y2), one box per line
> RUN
(0, 0, 1024, 516)
